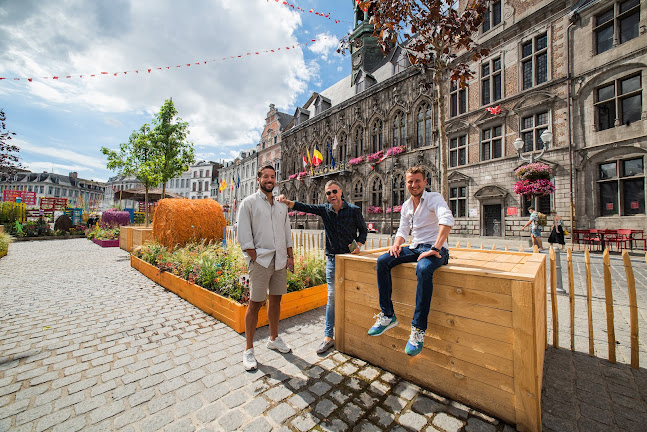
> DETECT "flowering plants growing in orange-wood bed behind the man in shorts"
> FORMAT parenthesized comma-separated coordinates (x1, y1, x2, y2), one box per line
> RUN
(133, 242, 326, 304)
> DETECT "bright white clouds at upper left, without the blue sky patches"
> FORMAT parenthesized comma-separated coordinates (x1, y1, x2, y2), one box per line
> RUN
(0, 0, 318, 159)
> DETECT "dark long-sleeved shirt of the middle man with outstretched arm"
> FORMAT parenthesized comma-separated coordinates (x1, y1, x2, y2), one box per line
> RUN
(294, 201, 368, 256)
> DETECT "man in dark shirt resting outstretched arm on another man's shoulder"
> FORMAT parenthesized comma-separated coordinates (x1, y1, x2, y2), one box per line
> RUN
(277, 180, 368, 354)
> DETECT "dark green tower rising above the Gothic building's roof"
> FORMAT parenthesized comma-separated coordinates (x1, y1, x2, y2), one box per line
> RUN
(348, 0, 384, 86)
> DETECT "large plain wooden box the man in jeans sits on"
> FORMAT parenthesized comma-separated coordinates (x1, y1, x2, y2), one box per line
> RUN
(335, 249, 546, 431)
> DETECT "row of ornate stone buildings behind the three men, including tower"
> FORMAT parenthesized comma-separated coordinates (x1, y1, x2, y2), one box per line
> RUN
(219, 0, 647, 236)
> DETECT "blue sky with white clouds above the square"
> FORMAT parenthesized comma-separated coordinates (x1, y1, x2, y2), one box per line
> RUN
(0, 0, 353, 181)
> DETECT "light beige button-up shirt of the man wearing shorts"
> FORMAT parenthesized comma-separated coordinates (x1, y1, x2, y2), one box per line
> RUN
(238, 189, 292, 270)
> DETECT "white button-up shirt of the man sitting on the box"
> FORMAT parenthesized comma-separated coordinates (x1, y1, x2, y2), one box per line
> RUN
(396, 191, 454, 249)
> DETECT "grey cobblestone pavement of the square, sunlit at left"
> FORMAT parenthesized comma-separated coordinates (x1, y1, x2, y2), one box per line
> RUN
(0, 239, 647, 432)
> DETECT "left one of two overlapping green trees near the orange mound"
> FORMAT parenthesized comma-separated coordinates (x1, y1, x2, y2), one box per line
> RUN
(101, 124, 162, 226)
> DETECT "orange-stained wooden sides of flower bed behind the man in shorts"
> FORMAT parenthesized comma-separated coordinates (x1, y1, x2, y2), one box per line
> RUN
(130, 256, 328, 333)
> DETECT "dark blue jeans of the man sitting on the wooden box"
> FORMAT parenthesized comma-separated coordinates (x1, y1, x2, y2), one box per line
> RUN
(377, 244, 449, 330)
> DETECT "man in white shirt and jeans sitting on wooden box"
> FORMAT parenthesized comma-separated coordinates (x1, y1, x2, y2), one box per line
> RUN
(368, 167, 454, 356)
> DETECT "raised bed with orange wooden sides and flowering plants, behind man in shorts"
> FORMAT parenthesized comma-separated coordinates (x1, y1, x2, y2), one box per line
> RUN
(130, 243, 328, 333)
